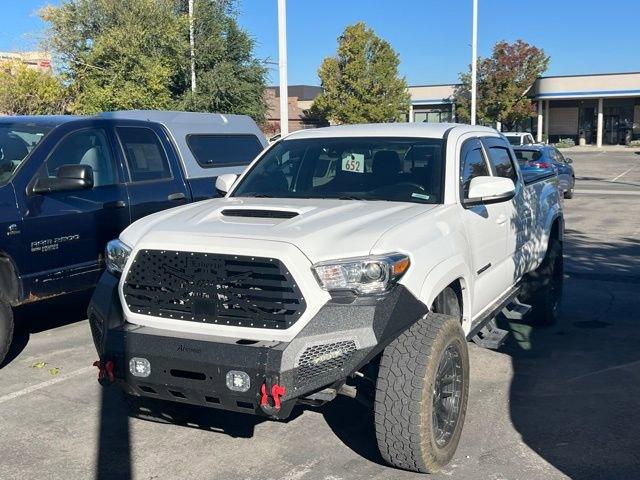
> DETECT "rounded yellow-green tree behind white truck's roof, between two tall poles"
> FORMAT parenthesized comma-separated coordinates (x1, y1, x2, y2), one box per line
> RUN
(312, 22, 409, 123)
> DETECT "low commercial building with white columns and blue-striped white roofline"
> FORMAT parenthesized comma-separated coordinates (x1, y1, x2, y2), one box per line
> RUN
(408, 72, 640, 147)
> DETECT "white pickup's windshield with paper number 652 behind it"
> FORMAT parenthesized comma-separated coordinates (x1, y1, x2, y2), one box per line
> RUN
(232, 137, 443, 203)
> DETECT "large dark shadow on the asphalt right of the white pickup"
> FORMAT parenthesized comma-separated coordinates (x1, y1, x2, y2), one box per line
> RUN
(503, 232, 640, 479)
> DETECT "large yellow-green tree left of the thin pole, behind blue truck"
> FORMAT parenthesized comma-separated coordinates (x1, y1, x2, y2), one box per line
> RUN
(41, 0, 188, 113)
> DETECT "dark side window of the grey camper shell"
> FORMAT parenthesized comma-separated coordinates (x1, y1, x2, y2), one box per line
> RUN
(187, 135, 262, 168)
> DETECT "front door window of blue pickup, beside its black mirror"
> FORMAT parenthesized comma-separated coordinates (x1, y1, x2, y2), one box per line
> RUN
(44, 128, 117, 187)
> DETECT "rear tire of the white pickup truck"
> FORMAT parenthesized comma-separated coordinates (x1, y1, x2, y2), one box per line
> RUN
(519, 238, 564, 326)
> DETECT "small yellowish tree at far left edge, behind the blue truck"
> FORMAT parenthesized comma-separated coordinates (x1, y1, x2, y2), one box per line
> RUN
(0, 61, 67, 115)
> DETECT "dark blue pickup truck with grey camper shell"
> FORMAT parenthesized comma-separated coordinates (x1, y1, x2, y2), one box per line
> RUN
(0, 111, 266, 363)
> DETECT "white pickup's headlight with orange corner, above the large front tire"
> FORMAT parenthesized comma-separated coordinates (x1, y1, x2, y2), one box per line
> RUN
(313, 253, 409, 295)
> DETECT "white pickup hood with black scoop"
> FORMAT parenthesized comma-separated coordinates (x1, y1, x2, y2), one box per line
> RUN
(120, 198, 436, 263)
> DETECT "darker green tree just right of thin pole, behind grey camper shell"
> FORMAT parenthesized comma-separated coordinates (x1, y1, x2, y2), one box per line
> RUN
(181, 0, 267, 123)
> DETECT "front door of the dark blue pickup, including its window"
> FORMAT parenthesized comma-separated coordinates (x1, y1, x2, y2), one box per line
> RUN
(24, 122, 130, 296)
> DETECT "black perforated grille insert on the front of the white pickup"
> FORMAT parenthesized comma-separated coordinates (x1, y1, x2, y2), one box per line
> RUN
(124, 250, 306, 329)
